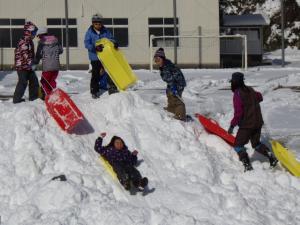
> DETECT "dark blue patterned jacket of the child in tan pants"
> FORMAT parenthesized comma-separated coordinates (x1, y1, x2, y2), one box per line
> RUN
(159, 59, 186, 95)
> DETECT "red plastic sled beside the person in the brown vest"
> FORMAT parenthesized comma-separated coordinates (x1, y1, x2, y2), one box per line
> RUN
(195, 113, 235, 146)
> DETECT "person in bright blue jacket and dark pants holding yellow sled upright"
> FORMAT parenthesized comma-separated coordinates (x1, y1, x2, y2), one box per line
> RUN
(84, 14, 119, 99)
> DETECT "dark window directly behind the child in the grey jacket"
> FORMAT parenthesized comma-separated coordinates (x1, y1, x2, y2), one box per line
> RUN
(47, 18, 78, 47)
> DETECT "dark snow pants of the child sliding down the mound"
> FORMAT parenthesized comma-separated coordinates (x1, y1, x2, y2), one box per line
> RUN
(112, 163, 142, 186)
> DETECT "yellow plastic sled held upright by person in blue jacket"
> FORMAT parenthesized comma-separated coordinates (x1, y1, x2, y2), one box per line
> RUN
(96, 38, 137, 91)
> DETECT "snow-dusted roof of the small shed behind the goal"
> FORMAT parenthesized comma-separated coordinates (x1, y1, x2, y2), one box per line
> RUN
(223, 14, 268, 26)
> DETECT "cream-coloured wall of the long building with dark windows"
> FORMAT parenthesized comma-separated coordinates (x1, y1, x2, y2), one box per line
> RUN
(0, 0, 220, 66)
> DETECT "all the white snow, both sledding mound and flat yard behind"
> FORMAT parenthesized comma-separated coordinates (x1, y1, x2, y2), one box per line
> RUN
(0, 51, 300, 225)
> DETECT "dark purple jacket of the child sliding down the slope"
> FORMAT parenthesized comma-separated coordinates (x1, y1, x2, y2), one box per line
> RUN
(95, 137, 137, 166)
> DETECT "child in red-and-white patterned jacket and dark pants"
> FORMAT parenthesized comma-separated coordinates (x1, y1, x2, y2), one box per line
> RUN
(13, 21, 39, 103)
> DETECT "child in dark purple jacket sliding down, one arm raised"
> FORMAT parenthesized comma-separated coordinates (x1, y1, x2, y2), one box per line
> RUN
(95, 133, 148, 190)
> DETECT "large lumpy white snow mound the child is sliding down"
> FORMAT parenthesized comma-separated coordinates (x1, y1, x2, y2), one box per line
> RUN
(0, 87, 300, 225)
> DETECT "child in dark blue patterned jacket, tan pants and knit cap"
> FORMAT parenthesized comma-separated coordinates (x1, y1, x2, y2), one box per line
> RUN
(154, 48, 186, 121)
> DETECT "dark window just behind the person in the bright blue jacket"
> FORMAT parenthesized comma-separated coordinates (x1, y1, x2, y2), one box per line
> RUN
(103, 18, 129, 47)
